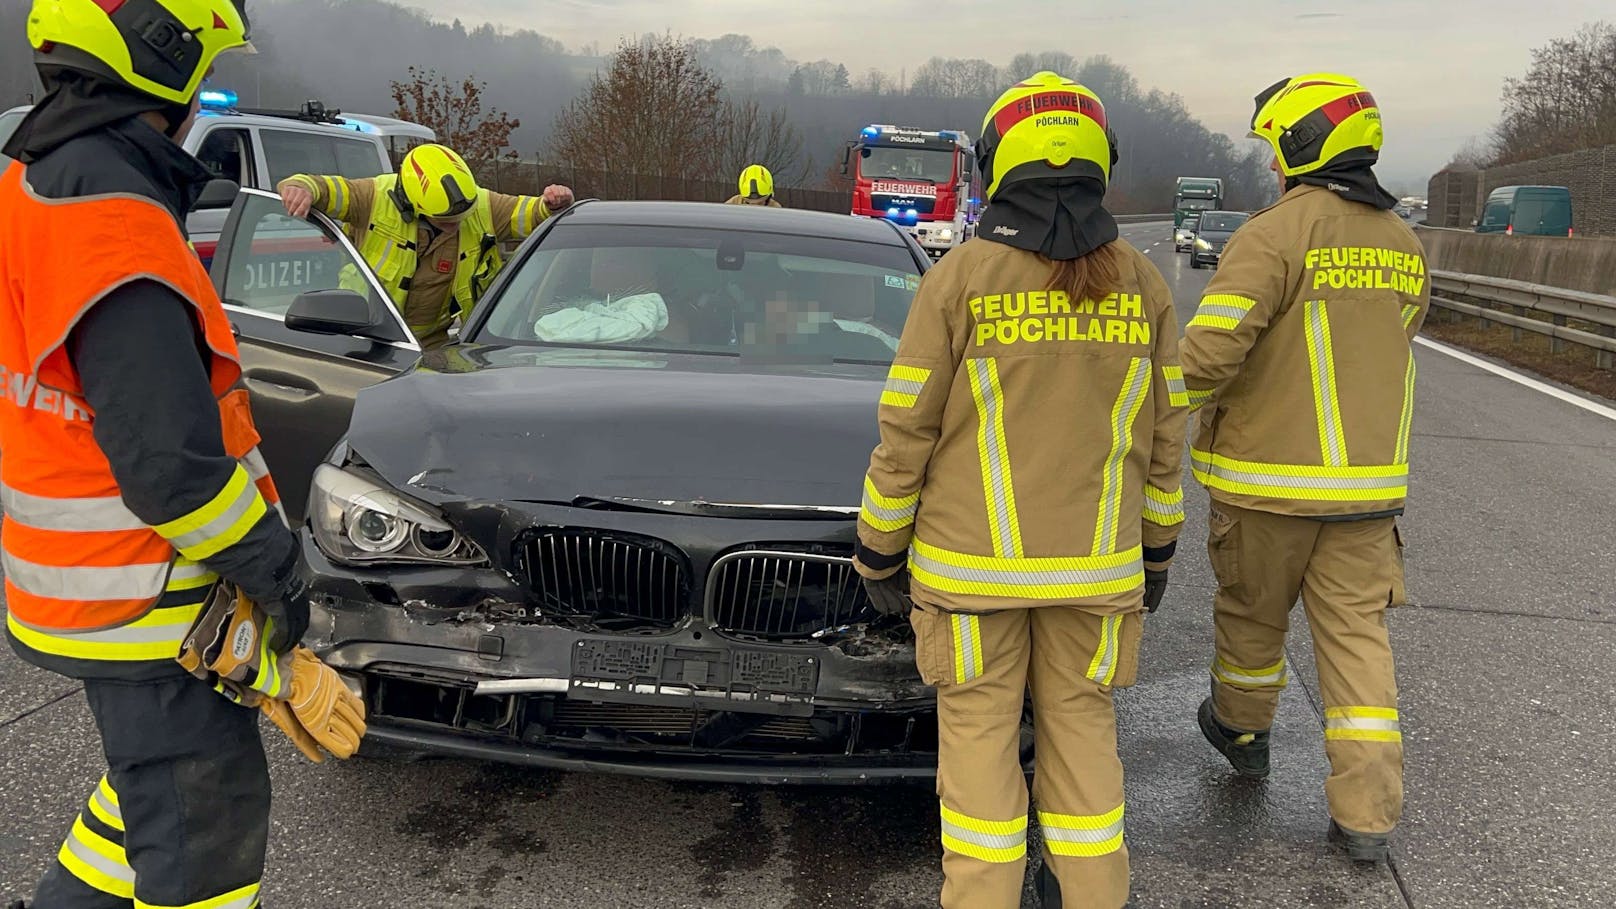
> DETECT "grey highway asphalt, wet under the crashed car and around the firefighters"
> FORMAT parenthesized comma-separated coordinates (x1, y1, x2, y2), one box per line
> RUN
(0, 223, 1616, 909)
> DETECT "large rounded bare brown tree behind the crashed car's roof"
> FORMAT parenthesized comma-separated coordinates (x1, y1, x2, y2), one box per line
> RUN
(551, 36, 724, 180)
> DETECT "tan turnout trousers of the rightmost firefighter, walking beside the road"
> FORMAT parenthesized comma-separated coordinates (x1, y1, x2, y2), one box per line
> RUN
(1207, 501, 1404, 833)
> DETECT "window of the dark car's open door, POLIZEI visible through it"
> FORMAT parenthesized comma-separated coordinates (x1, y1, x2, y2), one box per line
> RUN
(223, 194, 372, 317)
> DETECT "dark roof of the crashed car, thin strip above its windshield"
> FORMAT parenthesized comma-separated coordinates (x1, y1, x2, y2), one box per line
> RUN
(556, 199, 905, 246)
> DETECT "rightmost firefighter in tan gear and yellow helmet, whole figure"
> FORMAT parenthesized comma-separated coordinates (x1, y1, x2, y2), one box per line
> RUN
(1183, 74, 1430, 860)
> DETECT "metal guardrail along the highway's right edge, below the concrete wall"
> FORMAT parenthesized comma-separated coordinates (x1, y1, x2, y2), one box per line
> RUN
(1430, 270, 1616, 369)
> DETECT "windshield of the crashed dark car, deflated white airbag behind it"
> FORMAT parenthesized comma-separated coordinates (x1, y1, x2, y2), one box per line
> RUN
(470, 225, 920, 364)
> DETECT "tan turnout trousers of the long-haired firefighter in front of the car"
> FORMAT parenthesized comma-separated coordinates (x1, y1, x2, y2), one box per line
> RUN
(910, 603, 1144, 909)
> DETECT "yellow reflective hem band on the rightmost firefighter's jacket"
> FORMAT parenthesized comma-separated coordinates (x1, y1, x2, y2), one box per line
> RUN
(1189, 448, 1409, 501)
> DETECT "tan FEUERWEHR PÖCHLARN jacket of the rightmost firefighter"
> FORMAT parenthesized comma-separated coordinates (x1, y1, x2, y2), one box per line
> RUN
(1183, 186, 1430, 516)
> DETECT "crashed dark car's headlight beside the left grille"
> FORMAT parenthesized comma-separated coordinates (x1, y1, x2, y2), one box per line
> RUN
(309, 464, 488, 564)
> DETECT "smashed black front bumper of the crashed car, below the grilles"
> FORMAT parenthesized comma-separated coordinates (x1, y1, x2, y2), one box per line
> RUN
(304, 534, 937, 783)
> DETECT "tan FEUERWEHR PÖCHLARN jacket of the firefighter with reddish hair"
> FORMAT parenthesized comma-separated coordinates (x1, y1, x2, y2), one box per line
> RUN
(858, 239, 1186, 611)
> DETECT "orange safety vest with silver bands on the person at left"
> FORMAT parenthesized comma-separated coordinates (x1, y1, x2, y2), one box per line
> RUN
(0, 163, 280, 643)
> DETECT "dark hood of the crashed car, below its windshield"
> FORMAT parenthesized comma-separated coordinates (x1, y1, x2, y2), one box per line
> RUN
(347, 345, 887, 508)
